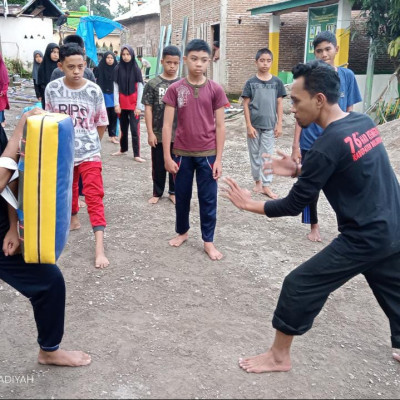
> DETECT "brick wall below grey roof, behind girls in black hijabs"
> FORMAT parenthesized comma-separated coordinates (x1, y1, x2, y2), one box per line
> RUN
(121, 14, 160, 57)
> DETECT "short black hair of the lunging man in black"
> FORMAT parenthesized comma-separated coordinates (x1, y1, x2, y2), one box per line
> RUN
(292, 60, 340, 104)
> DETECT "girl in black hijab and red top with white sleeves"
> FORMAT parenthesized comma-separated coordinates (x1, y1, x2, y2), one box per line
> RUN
(113, 45, 146, 162)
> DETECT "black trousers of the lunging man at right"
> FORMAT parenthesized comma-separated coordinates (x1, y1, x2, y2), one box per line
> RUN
(272, 245, 400, 348)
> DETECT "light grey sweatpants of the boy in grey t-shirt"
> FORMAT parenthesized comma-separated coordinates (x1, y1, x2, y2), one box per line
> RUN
(247, 129, 275, 186)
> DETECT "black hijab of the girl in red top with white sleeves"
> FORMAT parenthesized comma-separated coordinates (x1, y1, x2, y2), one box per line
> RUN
(114, 44, 143, 96)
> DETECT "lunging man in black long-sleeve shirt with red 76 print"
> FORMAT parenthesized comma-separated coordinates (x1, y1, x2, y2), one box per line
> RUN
(225, 61, 400, 373)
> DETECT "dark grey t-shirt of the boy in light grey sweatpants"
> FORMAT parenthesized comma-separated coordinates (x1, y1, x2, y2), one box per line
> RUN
(242, 76, 286, 130)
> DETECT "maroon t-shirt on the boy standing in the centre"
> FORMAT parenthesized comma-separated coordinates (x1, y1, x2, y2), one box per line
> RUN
(163, 78, 228, 152)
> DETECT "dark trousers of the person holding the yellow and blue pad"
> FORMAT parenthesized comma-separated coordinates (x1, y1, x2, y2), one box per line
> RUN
(0, 252, 65, 351)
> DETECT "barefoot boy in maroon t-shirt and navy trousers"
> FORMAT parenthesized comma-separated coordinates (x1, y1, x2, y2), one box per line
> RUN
(162, 39, 228, 260)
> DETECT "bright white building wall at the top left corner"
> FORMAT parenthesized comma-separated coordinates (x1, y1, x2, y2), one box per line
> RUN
(0, 16, 54, 71)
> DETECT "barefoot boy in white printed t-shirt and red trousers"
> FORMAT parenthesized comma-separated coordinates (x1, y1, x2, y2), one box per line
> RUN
(46, 44, 109, 268)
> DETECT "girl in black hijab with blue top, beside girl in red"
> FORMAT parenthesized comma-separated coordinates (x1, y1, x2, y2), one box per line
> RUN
(94, 51, 119, 144)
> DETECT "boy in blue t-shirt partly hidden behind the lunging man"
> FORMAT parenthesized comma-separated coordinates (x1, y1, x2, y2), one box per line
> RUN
(292, 31, 362, 242)
